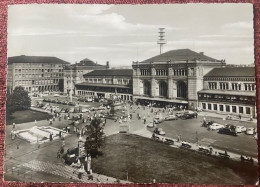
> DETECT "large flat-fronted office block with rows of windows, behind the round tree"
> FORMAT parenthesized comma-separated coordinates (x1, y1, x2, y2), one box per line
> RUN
(7, 55, 69, 92)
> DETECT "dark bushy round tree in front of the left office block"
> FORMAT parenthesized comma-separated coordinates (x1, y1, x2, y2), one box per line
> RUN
(6, 86, 31, 116)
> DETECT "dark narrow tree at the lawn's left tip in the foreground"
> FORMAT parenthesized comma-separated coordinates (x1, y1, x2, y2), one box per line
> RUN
(85, 118, 105, 157)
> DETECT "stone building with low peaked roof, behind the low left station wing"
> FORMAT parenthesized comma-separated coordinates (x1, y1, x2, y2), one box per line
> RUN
(63, 58, 109, 95)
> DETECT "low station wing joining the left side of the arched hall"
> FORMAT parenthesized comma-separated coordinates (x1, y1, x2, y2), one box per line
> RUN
(75, 69, 133, 100)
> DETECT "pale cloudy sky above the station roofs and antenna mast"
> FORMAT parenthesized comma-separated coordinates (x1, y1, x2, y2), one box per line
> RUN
(7, 4, 254, 66)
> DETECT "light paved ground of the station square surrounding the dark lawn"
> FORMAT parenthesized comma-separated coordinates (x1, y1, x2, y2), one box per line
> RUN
(4, 96, 257, 183)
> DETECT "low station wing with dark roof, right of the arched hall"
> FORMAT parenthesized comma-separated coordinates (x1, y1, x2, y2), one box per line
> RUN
(198, 67, 256, 117)
